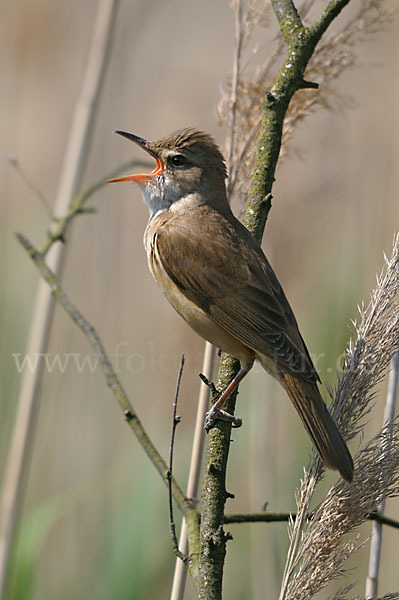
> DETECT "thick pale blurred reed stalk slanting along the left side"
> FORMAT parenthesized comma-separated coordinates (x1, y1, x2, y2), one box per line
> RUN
(0, 0, 118, 598)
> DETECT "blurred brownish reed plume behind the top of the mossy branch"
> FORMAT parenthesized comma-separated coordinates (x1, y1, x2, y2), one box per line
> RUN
(218, 0, 391, 210)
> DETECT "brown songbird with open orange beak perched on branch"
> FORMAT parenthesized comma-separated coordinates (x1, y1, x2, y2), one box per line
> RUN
(108, 128, 354, 482)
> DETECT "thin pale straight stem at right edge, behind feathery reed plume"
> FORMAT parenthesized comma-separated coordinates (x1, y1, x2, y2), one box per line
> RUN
(366, 352, 399, 598)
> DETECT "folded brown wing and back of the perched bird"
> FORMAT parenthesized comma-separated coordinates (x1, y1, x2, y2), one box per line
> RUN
(156, 206, 318, 381)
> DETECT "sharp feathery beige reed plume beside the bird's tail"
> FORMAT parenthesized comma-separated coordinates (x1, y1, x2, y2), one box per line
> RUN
(280, 234, 399, 600)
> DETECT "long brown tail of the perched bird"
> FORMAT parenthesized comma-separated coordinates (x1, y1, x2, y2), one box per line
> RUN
(280, 373, 353, 481)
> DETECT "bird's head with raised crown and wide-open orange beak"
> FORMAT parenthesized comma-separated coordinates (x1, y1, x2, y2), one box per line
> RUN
(108, 129, 227, 215)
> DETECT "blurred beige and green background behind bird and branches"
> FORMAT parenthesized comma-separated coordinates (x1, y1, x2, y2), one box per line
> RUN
(0, 0, 399, 600)
